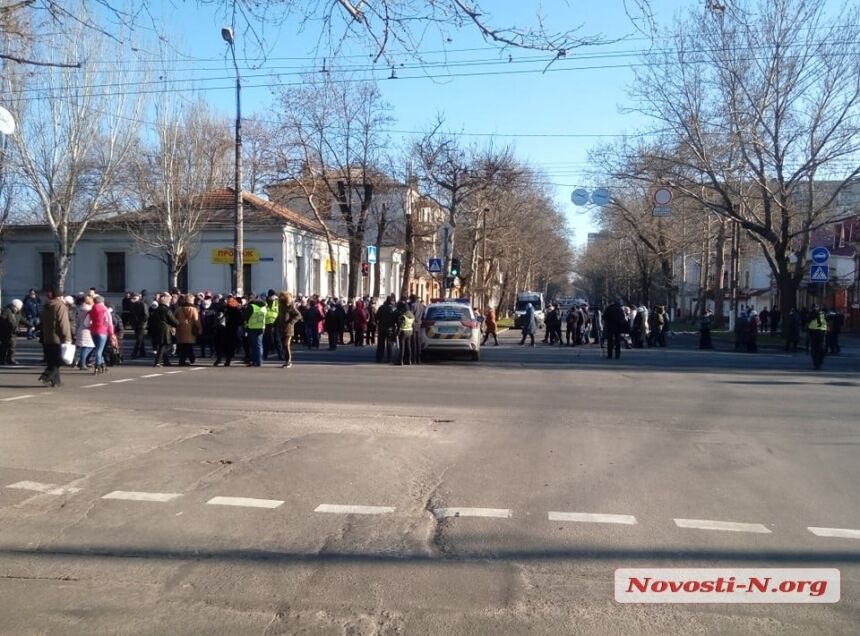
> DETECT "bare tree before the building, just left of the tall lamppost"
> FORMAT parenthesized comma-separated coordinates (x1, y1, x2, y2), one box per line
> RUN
(122, 98, 233, 287)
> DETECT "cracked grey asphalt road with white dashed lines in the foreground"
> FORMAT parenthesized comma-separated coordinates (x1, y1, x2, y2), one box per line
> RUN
(0, 334, 860, 634)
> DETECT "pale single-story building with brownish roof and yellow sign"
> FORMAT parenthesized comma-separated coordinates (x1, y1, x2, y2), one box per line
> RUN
(0, 188, 402, 302)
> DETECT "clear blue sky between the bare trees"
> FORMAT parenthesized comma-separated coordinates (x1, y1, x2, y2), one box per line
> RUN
(124, 0, 701, 243)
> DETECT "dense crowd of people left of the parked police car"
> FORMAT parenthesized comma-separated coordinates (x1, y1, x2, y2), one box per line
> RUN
(0, 288, 430, 386)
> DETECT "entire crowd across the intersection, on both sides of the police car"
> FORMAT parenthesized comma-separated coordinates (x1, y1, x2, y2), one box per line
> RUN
(0, 288, 845, 386)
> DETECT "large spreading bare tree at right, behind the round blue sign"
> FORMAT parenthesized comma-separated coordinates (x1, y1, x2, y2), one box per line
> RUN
(634, 0, 860, 314)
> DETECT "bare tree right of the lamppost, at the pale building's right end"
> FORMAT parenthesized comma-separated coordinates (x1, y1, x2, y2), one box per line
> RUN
(276, 79, 391, 298)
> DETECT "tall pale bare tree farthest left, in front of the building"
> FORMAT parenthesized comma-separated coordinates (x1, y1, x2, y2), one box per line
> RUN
(5, 21, 141, 293)
